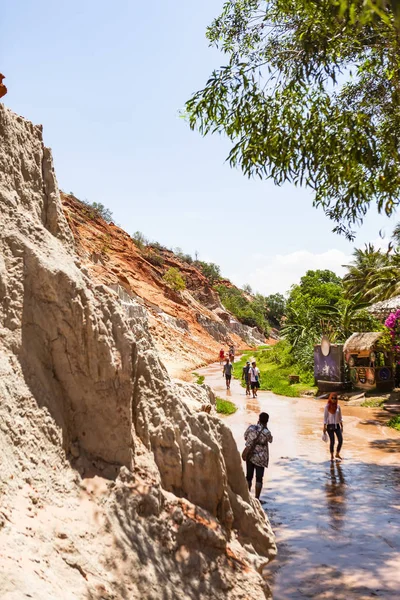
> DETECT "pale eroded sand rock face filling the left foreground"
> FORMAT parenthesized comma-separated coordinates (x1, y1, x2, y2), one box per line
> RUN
(0, 105, 276, 600)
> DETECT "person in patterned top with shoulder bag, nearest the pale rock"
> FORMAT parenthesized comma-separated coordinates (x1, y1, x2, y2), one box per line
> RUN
(242, 412, 273, 498)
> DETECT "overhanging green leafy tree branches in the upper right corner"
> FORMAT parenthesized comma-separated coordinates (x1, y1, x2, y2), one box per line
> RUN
(186, 0, 400, 238)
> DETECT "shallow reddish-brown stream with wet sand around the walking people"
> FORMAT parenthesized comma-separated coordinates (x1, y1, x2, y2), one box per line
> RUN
(198, 364, 400, 600)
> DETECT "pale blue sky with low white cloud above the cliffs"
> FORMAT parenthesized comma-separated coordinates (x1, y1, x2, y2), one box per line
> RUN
(0, 0, 396, 294)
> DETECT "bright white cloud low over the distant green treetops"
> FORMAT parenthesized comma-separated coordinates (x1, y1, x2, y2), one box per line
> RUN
(231, 249, 351, 295)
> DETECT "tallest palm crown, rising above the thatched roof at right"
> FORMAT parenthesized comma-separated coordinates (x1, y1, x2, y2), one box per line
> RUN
(343, 244, 391, 301)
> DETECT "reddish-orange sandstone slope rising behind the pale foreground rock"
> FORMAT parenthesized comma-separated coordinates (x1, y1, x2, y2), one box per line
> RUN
(61, 194, 265, 377)
